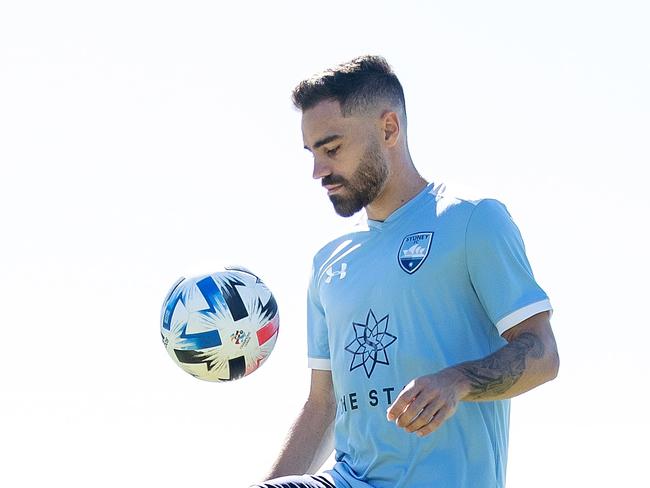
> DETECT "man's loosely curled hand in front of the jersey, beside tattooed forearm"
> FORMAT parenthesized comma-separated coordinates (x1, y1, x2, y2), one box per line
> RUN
(386, 368, 469, 436)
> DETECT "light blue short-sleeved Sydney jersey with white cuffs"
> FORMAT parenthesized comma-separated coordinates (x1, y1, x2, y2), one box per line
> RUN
(308, 185, 551, 488)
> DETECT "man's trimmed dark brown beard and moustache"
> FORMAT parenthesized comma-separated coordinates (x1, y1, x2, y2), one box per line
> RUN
(322, 141, 388, 217)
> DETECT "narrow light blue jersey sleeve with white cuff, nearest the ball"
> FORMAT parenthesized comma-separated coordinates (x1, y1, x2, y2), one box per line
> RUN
(307, 266, 332, 370)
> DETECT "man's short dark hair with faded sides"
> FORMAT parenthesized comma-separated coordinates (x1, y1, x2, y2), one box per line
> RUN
(292, 55, 406, 118)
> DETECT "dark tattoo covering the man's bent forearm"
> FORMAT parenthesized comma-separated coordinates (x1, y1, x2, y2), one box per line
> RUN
(457, 332, 544, 400)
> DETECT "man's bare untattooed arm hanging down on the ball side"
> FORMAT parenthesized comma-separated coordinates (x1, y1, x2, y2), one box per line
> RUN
(267, 369, 336, 479)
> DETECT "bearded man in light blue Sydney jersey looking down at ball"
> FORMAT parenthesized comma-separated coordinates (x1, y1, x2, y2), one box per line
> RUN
(252, 56, 559, 488)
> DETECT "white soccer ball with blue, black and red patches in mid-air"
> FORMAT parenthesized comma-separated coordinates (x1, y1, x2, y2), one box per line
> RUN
(160, 267, 280, 381)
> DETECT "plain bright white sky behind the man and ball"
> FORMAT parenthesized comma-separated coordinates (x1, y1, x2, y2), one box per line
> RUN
(0, 0, 650, 488)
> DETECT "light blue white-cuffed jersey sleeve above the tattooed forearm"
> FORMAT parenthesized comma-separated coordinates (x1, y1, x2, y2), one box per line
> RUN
(465, 200, 552, 334)
